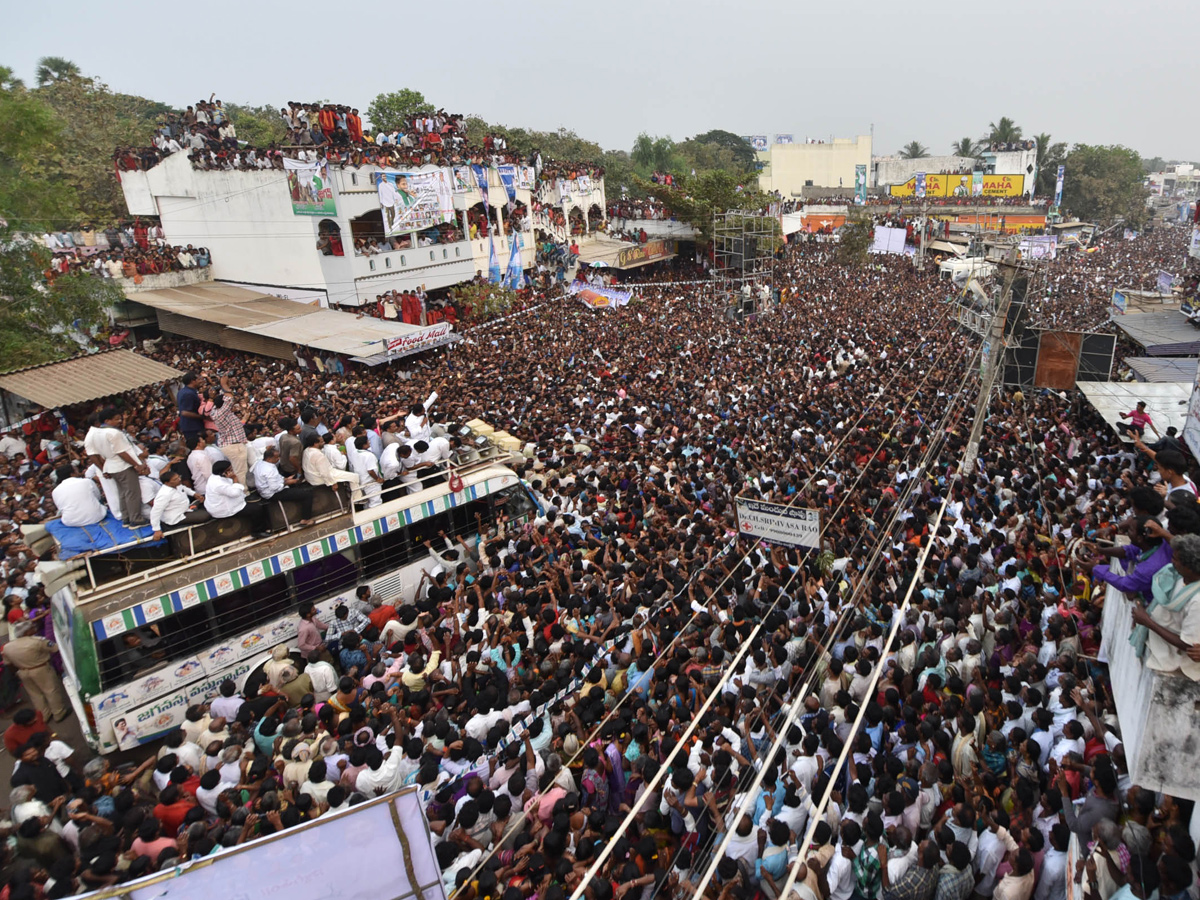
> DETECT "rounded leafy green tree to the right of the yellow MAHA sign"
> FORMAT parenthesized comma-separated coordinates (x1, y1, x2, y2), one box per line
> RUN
(1062, 144, 1147, 228)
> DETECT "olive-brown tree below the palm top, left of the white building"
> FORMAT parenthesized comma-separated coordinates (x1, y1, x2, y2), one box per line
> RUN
(35, 78, 159, 224)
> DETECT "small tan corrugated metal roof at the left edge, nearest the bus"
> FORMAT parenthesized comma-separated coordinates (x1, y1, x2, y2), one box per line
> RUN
(0, 350, 182, 409)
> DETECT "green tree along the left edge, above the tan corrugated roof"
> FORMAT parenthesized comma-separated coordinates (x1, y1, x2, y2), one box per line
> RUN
(0, 86, 121, 368)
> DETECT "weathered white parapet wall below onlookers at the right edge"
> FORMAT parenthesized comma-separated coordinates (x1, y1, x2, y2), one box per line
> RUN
(1100, 573, 1200, 800)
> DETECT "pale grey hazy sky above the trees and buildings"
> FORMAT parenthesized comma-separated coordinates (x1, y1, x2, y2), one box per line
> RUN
(0, 0, 1200, 160)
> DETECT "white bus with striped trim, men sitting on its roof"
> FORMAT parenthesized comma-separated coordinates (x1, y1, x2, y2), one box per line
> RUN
(34, 461, 534, 752)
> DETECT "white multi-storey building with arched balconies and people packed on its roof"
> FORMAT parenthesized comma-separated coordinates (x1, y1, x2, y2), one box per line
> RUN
(121, 152, 605, 306)
